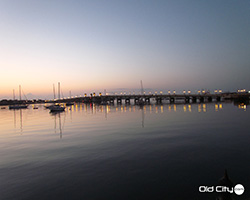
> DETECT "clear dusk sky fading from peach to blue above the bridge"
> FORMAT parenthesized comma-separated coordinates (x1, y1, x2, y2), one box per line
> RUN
(0, 0, 250, 99)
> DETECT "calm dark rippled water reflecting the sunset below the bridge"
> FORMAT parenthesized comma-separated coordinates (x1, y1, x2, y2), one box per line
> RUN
(0, 103, 250, 200)
